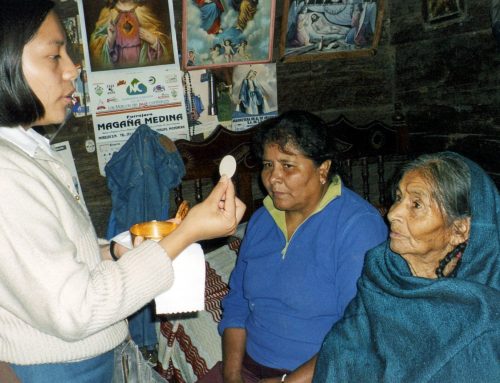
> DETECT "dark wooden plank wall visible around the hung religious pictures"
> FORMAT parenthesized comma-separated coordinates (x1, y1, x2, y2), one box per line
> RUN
(52, 0, 500, 240)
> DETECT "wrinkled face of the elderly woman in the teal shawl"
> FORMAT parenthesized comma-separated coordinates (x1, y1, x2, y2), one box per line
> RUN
(387, 170, 458, 263)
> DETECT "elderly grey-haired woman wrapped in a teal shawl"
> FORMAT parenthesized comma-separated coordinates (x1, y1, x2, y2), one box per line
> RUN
(314, 152, 500, 383)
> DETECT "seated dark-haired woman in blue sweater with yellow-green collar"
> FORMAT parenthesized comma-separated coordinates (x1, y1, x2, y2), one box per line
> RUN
(200, 111, 387, 383)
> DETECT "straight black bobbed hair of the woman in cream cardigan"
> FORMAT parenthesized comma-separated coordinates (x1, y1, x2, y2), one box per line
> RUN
(0, 0, 54, 127)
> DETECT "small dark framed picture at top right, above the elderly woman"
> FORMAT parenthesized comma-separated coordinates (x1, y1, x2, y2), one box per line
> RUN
(422, 0, 466, 28)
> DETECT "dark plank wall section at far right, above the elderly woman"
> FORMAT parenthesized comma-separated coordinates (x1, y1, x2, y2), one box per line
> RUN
(390, 0, 500, 185)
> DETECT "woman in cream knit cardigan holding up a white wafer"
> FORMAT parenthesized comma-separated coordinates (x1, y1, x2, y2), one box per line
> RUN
(0, 0, 245, 383)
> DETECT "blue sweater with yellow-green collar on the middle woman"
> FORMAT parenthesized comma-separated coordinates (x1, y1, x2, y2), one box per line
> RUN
(219, 183, 387, 370)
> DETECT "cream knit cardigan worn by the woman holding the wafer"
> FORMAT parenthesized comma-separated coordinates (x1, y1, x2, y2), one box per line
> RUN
(0, 138, 173, 364)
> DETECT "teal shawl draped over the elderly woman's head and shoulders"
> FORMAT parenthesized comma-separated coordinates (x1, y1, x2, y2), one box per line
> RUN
(313, 154, 500, 383)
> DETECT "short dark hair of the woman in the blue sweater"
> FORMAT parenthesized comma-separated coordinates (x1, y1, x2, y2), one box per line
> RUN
(254, 110, 337, 180)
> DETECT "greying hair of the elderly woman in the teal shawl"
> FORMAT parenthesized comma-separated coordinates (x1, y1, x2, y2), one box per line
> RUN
(399, 152, 471, 225)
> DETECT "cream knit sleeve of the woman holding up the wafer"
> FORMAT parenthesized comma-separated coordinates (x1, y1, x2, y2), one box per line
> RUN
(0, 169, 173, 340)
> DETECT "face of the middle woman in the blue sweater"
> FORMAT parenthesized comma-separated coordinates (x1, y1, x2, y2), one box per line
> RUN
(261, 144, 330, 216)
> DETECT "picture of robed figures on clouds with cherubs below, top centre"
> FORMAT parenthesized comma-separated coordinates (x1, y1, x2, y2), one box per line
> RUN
(182, 0, 275, 70)
